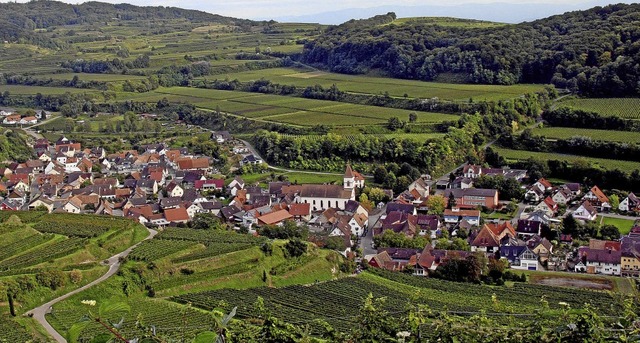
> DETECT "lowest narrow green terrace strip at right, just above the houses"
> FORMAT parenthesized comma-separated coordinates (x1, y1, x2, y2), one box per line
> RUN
(493, 147, 640, 172)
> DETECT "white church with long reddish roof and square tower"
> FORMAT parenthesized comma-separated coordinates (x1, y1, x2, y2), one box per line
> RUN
(297, 165, 364, 211)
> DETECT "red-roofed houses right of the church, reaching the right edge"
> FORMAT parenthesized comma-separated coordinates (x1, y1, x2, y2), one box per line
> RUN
(367, 165, 640, 276)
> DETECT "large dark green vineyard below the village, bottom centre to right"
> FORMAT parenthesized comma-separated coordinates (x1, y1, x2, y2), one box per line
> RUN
(171, 270, 615, 331)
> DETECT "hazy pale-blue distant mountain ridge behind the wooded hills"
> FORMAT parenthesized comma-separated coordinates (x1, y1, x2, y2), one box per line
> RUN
(264, 0, 631, 25)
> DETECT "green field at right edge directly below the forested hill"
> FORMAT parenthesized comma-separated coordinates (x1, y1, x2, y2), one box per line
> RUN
(559, 98, 640, 119)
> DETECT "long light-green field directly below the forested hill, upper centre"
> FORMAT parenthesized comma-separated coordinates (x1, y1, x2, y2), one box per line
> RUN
(202, 68, 543, 101)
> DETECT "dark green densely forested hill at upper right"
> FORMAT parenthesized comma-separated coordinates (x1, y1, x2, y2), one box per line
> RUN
(302, 4, 640, 96)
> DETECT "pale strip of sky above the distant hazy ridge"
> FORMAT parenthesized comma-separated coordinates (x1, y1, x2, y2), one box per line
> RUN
(0, 0, 630, 19)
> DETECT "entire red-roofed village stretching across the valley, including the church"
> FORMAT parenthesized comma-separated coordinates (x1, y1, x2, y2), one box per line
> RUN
(0, 109, 640, 277)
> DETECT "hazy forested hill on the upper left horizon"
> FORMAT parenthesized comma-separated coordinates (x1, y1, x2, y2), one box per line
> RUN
(0, 0, 251, 45)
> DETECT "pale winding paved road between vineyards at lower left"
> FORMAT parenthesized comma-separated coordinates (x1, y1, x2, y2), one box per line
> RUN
(26, 229, 158, 343)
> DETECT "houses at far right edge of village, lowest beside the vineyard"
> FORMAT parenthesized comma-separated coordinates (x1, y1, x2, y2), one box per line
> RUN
(574, 227, 640, 277)
